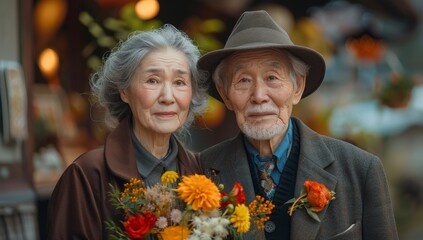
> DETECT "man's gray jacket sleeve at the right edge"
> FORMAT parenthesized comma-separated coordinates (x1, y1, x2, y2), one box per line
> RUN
(362, 159, 398, 239)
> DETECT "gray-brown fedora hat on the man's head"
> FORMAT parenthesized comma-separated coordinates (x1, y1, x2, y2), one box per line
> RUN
(198, 10, 326, 100)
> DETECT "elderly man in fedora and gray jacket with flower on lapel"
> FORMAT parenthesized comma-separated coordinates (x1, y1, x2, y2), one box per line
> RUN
(198, 11, 398, 240)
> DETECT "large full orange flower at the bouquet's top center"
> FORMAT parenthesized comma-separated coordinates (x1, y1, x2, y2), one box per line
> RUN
(175, 174, 221, 211)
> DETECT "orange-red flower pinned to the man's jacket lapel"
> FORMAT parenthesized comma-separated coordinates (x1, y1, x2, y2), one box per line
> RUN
(304, 181, 332, 212)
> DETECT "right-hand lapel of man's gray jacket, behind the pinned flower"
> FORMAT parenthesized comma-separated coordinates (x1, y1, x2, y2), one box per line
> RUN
(291, 119, 337, 239)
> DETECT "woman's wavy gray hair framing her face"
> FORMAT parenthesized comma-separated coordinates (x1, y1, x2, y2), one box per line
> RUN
(90, 24, 207, 136)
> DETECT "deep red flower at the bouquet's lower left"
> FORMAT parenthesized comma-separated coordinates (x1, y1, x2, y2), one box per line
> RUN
(123, 212, 157, 239)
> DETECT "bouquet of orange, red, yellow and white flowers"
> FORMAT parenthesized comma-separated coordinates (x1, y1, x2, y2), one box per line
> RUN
(106, 171, 274, 240)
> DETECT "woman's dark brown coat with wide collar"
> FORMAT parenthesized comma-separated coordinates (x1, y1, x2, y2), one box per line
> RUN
(48, 119, 201, 240)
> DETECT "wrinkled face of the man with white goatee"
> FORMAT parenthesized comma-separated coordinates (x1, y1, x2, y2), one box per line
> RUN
(217, 49, 305, 140)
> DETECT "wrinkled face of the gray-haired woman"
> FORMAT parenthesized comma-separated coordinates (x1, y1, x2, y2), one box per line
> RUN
(120, 48, 192, 134)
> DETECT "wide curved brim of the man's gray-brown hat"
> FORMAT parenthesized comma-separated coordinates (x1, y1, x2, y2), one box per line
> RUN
(197, 43, 326, 101)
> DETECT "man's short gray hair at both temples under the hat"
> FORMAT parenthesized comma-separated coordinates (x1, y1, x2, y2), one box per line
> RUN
(212, 49, 310, 94)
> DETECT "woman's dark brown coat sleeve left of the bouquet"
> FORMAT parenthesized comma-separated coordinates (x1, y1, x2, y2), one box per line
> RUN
(48, 163, 103, 239)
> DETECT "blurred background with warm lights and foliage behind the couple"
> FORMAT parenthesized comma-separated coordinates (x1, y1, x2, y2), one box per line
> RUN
(0, 0, 423, 240)
